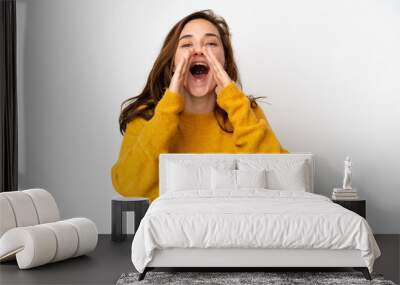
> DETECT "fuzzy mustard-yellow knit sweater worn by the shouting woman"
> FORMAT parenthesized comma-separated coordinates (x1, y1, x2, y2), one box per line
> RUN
(111, 82, 289, 201)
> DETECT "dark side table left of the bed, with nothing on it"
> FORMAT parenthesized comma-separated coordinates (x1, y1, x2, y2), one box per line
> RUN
(111, 197, 150, 241)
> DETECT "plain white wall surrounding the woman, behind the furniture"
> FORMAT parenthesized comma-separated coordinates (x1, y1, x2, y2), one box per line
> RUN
(17, 0, 400, 233)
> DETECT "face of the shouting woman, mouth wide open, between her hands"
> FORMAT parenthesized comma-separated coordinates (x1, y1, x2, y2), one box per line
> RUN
(174, 19, 225, 97)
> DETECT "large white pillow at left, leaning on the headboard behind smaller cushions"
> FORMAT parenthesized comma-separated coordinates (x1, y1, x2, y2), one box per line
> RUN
(166, 160, 236, 191)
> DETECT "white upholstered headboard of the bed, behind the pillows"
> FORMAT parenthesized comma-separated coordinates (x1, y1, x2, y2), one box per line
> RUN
(159, 152, 315, 195)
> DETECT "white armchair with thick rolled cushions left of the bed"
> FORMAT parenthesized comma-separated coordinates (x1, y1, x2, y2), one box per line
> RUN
(0, 188, 98, 269)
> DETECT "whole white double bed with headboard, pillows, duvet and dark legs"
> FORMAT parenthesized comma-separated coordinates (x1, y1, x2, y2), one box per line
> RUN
(131, 153, 381, 280)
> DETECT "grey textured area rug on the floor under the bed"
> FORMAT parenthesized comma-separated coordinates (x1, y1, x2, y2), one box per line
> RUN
(116, 271, 396, 285)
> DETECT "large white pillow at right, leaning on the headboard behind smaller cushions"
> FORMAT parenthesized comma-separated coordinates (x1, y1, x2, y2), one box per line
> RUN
(238, 159, 311, 191)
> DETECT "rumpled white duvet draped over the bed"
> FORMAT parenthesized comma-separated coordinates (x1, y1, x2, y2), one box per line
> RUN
(131, 188, 381, 272)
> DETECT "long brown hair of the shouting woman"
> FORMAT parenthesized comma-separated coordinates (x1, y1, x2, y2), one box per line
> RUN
(119, 10, 264, 135)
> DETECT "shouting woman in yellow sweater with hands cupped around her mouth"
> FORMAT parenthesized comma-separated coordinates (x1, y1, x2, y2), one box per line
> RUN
(111, 10, 288, 201)
